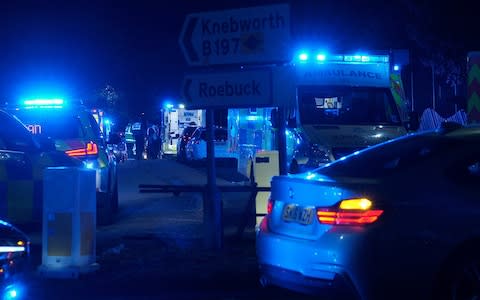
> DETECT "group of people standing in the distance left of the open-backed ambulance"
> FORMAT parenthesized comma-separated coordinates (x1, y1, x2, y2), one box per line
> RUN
(132, 116, 162, 160)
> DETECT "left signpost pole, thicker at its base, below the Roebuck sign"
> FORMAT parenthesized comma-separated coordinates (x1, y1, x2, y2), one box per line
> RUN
(203, 108, 223, 250)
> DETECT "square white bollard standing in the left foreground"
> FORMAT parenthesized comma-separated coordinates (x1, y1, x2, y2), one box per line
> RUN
(38, 167, 99, 278)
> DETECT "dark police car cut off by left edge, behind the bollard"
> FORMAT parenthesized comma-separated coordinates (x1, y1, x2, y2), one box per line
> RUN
(0, 110, 81, 224)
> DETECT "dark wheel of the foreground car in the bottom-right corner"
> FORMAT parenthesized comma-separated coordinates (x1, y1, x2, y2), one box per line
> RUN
(434, 247, 480, 300)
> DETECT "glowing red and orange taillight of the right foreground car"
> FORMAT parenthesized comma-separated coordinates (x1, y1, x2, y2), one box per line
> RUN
(317, 198, 383, 225)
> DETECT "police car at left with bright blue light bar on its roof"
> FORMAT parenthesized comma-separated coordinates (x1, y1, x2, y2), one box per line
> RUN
(6, 99, 118, 224)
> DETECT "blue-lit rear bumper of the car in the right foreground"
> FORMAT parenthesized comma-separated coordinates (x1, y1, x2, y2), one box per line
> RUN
(256, 217, 369, 299)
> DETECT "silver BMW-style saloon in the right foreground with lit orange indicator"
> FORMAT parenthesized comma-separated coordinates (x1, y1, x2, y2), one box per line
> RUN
(256, 122, 480, 299)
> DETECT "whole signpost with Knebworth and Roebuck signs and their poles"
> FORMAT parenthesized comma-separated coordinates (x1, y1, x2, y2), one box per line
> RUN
(179, 4, 295, 249)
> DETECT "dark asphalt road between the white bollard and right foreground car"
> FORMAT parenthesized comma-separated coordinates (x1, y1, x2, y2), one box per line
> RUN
(18, 159, 320, 300)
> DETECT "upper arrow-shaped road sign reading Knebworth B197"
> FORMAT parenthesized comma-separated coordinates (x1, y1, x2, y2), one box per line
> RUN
(180, 4, 291, 66)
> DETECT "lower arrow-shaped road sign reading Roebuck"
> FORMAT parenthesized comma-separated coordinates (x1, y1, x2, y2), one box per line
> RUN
(183, 67, 295, 109)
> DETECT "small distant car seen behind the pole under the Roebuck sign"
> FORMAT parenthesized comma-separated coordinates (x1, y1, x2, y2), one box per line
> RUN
(185, 127, 233, 160)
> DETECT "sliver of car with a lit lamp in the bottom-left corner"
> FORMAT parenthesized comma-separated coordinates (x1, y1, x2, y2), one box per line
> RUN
(0, 220, 31, 299)
